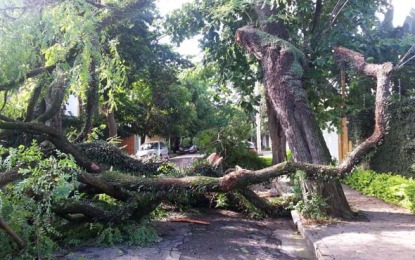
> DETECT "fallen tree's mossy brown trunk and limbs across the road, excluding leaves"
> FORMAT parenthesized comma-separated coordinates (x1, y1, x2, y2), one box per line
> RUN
(0, 42, 393, 254)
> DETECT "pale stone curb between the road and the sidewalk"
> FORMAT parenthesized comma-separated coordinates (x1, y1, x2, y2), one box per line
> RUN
(291, 210, 336, 260)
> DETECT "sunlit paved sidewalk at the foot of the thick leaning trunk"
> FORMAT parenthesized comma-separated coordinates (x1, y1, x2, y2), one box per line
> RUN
(293, 186, 415, 260)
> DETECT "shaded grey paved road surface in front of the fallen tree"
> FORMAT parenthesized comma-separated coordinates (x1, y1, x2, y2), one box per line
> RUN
(64, 209, 314, 260)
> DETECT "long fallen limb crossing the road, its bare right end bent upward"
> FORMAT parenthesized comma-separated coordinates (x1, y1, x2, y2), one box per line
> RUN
(74, 47, 393, 218)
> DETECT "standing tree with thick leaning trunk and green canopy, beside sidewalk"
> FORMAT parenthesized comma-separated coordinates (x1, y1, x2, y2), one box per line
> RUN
(168, 1, 396, 218)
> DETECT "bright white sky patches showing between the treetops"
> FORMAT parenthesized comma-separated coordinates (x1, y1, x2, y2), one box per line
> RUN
(157, 0, 415, 55)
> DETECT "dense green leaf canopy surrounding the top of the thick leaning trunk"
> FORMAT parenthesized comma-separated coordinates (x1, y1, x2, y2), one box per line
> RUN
(166, 0, 414, 128)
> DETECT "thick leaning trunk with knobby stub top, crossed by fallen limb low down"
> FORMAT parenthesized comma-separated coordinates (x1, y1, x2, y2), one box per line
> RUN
(235, 26, 353, 218)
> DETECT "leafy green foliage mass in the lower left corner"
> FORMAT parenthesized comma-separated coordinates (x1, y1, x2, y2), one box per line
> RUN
(0, 142, 78, 259)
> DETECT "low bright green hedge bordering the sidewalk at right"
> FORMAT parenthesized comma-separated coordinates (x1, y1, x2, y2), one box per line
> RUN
(344, 169, 415, 213)
